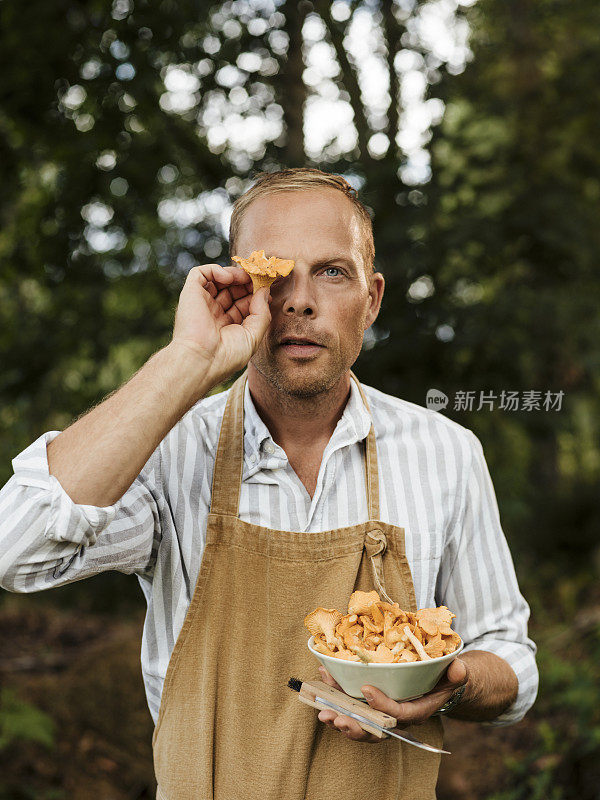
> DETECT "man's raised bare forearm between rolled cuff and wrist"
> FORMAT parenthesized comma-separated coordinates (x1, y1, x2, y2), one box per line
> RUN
(47, 342, 214, 506)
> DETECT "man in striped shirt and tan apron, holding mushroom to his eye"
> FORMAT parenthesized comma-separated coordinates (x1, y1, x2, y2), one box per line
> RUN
(0, 169, 537, 800)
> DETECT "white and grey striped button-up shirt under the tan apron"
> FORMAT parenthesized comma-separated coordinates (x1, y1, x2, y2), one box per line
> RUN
(0, 381, 538, 725)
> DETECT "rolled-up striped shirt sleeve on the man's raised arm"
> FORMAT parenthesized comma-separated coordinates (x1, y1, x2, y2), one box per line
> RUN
(0, 431, 163, 592)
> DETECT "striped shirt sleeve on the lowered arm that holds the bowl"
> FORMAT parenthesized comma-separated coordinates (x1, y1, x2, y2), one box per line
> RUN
(436, 431, 539, 726)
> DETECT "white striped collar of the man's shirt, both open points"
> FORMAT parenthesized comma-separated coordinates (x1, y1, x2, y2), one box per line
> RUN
(244, 378, 371, 471)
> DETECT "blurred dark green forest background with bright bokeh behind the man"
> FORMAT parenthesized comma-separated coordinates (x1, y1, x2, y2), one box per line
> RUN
(0, 0, 600, 800)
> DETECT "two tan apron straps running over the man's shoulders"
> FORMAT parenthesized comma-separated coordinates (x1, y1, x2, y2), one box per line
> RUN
(210, 370, 379, 519)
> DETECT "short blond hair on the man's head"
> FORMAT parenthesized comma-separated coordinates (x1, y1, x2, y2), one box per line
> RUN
(229, 167, 375, 276)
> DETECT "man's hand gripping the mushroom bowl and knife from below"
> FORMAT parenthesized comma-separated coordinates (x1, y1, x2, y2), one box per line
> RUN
(319, 658, 468, 743)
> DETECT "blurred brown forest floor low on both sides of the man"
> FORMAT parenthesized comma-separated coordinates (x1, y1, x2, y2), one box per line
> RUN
(0, 595, 532, 800)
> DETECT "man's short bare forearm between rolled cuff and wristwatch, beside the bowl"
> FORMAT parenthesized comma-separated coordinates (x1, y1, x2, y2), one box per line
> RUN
(448, 650, 519, 722)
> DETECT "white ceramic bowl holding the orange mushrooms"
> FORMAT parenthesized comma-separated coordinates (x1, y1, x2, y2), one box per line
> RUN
(308, 636, 464, 700)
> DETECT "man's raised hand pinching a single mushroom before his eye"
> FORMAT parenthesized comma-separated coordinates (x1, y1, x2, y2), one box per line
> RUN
(172, 264, 271, 383)
